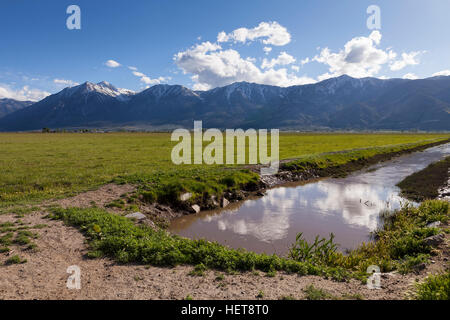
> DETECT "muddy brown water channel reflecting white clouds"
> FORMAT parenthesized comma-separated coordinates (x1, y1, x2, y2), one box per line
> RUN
(170, 144, 450, 255)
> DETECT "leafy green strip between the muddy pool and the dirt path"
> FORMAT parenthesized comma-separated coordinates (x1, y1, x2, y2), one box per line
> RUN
(51, 201, 449, 280)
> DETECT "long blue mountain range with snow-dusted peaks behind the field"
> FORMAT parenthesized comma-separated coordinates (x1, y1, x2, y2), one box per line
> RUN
(0, 75, 450, 131)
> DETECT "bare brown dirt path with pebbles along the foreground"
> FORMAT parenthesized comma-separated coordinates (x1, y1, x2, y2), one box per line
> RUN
(0, 208, 449, 299)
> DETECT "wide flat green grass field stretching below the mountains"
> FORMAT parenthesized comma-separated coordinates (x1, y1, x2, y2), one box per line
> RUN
(0, 133, 449, 207)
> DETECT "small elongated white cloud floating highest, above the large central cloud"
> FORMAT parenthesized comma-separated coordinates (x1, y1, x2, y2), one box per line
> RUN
(217, 21, 291, 46)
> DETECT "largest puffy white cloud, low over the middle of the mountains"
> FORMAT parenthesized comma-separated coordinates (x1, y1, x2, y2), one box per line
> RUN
(174, 42, 315, 90)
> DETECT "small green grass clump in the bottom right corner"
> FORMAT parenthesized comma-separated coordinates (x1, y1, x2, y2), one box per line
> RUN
(415, 271, 450, 301)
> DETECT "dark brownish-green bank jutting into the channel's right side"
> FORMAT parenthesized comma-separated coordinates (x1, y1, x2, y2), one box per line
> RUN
(397, 157, 450, 202)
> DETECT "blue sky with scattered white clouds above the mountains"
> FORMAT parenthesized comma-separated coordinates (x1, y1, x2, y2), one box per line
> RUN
(0, 0, 450, 100)
